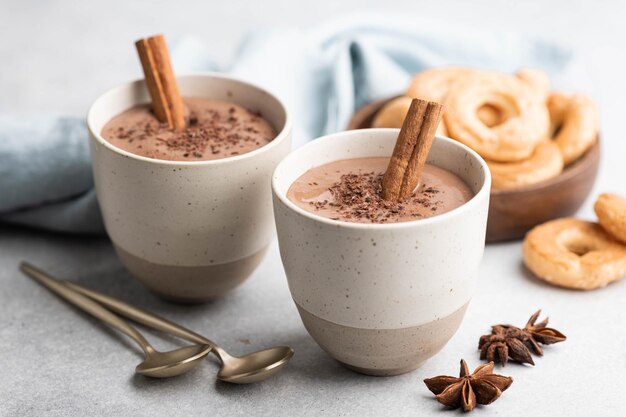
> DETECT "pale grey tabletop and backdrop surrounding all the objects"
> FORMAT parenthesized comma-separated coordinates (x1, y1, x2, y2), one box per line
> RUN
(0, 0, 626, 416)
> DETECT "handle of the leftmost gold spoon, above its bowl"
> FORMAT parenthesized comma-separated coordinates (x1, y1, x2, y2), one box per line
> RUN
(20, 262, 152, 352)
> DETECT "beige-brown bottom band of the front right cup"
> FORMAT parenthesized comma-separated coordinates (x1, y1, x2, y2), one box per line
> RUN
(296, 303, 467, 376)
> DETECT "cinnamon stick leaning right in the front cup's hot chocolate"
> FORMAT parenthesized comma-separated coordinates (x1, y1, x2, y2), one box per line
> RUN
(382, 99, 443, 201)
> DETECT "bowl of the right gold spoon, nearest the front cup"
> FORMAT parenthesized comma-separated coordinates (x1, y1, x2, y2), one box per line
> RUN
(217, 346, 293, 384)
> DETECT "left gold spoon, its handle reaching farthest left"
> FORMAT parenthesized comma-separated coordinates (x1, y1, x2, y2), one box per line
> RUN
(20, 262, 211, 378)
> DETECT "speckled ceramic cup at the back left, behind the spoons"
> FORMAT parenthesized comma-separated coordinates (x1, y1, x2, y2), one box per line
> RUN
(87, 73, 291, 302)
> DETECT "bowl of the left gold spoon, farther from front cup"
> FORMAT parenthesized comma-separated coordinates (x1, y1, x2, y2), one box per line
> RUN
(135, 345, 211, 378)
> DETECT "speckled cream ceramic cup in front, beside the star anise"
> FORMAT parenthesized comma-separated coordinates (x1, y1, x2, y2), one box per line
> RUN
(272, 129, 491, 375)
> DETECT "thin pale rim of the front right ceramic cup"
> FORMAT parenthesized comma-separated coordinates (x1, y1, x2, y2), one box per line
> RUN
(272, 128, 491, 230)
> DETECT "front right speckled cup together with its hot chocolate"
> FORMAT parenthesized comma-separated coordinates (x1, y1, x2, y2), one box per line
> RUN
(272, 129, 490, 375)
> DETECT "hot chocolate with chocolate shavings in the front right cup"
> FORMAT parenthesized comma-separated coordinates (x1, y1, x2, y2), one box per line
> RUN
(287, 157, 474, 223)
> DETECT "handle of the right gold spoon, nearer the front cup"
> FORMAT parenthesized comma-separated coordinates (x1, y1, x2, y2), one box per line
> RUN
(63, 281, 217, 349)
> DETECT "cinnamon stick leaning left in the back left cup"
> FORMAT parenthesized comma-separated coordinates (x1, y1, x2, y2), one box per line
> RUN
(135, 35, 185, 129)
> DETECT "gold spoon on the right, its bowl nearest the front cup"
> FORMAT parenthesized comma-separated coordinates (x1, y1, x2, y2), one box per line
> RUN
(63, 281, 293, 384)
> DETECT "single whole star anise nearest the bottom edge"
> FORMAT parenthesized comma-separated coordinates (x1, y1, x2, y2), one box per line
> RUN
(424, 359, 513, 411)
